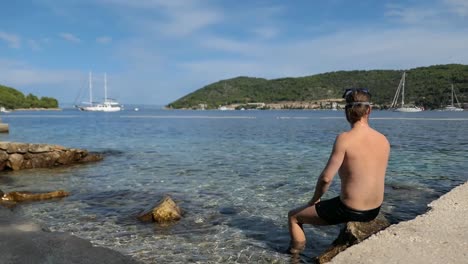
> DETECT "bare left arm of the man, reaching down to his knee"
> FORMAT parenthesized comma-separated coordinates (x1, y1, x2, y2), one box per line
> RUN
(308, 133, 346, 205)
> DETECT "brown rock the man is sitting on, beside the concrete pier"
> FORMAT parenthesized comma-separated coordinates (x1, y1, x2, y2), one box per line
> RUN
(315, 214, 390, 263)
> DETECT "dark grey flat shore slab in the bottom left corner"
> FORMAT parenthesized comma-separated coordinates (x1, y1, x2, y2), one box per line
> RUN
(0, 206, 140, 264)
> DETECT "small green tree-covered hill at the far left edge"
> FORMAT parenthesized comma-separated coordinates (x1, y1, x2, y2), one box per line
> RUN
(0, 85, 58, 109)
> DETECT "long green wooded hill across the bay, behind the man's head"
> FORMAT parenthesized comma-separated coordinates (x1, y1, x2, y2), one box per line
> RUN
(167, 64, 468, 109)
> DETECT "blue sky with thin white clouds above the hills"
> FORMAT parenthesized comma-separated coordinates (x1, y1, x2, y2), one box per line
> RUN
(0, 0, 468, 106)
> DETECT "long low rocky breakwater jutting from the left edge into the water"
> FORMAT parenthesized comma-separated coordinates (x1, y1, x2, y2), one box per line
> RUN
(0, 141, 103, 171)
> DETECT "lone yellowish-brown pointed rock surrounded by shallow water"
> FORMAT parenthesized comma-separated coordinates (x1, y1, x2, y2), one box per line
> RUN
(138, 196, 182, 223)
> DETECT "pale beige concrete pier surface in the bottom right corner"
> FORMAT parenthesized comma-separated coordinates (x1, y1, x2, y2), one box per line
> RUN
(330, 182, 468, 264)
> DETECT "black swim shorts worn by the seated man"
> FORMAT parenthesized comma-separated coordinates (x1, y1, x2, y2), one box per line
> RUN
(315, 196, 380, 225)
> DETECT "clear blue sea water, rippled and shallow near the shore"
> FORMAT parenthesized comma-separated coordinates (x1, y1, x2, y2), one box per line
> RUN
(0, 107, 468, 263)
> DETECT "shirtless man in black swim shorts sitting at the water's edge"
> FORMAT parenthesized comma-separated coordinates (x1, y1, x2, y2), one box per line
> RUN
(288, 89, 390, 254)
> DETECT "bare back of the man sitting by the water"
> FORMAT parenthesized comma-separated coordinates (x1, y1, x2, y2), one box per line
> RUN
(337, 125, 390, 210)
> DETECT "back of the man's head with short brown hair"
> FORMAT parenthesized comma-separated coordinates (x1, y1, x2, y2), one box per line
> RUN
(345, 89, 370, 124)
